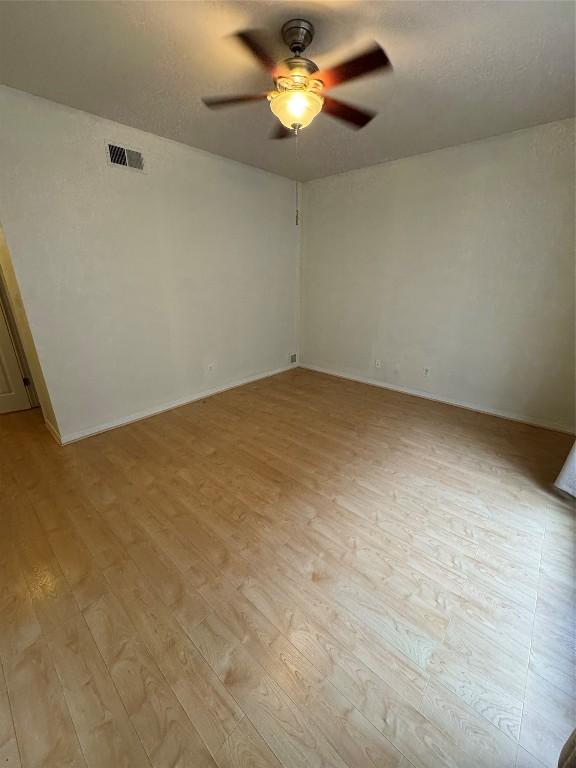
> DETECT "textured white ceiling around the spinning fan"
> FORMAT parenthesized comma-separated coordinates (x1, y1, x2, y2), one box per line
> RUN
(0, 0, 575, 180)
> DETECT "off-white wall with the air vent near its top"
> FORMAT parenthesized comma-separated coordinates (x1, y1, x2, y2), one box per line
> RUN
(0, 87, 299, 441)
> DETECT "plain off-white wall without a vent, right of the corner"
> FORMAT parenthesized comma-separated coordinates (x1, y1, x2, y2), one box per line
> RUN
(301, 120, 575, 429)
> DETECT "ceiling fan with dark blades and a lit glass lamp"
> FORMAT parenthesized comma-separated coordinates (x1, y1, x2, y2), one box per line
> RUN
(202, 19, 392, 139)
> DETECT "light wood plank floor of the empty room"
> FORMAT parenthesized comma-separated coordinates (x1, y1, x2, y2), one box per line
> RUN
(0, 370, 576, 768)
